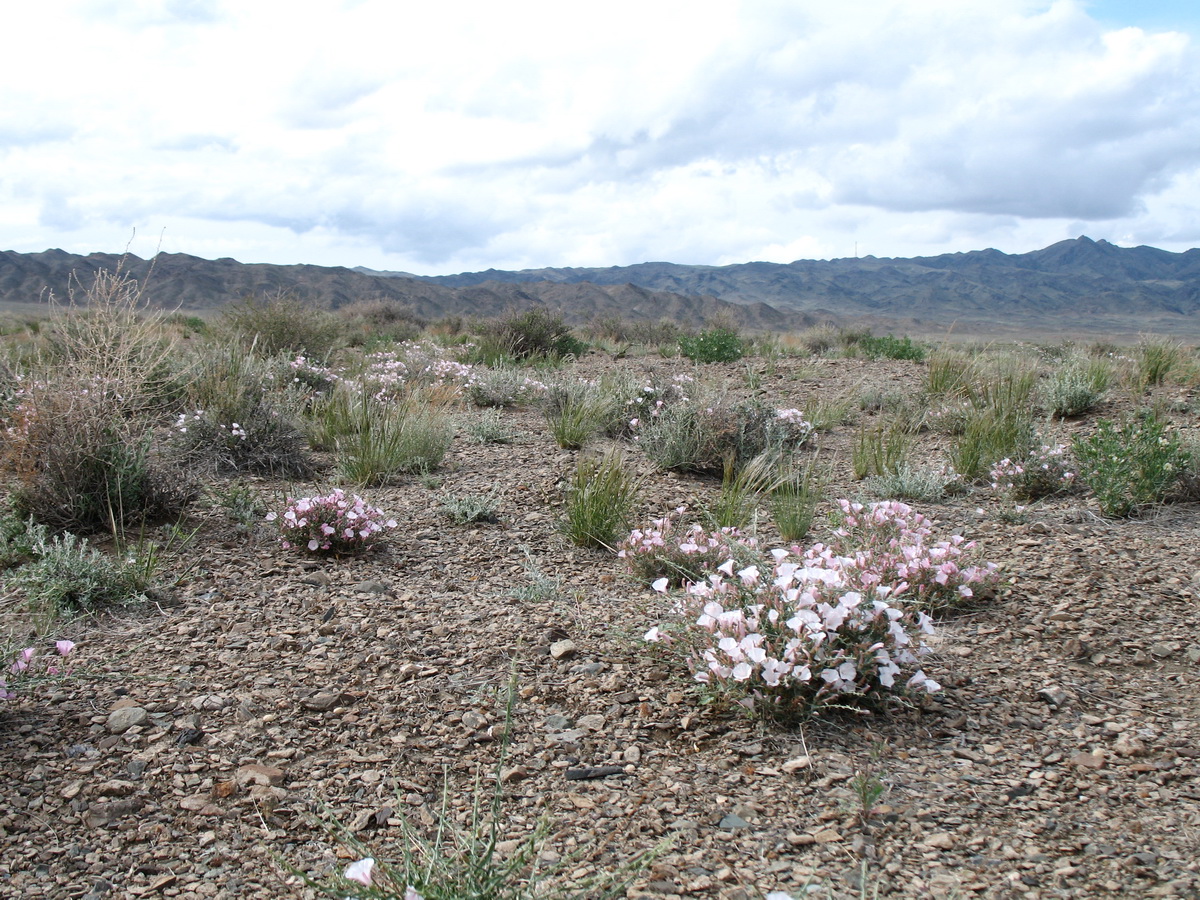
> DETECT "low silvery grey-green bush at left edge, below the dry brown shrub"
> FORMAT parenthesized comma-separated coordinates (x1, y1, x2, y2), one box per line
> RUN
(10, 533, 150, 612)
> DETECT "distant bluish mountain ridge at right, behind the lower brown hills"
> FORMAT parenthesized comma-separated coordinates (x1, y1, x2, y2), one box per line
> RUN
(400, 236, 1200, 320)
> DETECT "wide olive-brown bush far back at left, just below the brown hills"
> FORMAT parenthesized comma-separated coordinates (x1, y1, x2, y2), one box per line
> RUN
(217, 290, 343, 360)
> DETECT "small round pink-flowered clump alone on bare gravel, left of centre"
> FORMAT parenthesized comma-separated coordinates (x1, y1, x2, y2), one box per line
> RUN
(266, 488, 396, 553)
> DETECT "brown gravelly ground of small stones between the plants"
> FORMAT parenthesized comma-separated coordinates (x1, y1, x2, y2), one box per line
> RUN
(0, 354, 1200, 900)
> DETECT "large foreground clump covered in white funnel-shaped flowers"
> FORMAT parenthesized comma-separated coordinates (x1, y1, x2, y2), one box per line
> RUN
(646, 550, 940, 720)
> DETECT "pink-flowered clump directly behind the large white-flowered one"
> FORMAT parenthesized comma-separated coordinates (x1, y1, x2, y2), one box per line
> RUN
(820, 499, 1000, 610)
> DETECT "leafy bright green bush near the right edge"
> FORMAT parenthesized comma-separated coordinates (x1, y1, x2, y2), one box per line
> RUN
(1072, 415, 1188, 517)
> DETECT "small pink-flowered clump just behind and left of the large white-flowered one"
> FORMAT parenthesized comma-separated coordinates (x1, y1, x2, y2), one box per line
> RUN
(617, 506, 757, 586)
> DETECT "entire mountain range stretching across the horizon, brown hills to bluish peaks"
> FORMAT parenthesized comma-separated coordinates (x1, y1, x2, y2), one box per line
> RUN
(0, 236, 1200, 334)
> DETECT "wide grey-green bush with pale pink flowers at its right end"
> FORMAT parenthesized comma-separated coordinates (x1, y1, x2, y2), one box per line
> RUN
(637, 396, 812, 474)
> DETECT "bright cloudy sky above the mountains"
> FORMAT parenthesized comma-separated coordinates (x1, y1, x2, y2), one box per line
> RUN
(0, 0, 1200, 275)
